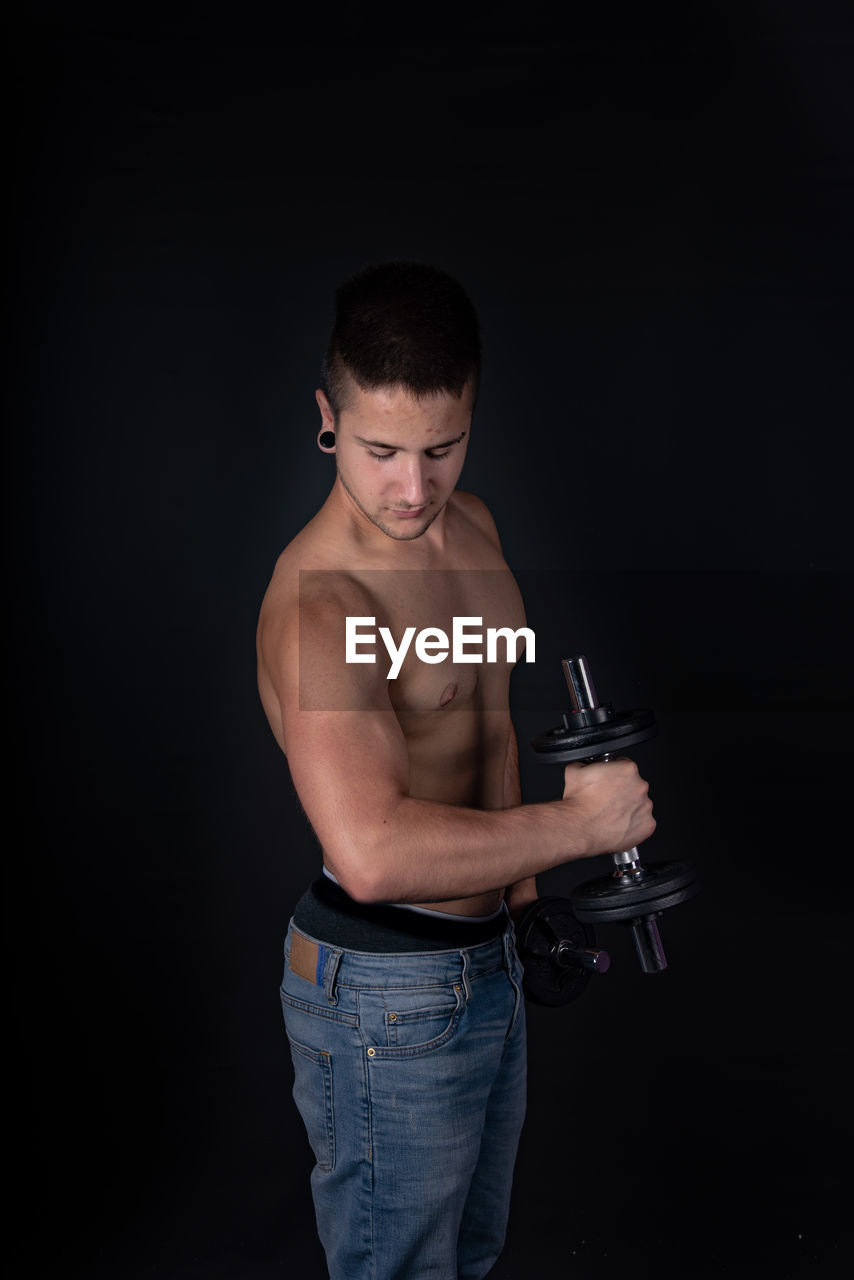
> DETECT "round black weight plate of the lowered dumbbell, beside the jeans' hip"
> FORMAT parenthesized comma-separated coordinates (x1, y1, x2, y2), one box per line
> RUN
(516, 897, 595, 1009)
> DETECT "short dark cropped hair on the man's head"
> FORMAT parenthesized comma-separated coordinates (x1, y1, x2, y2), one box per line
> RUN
(323, 262, 480, 417)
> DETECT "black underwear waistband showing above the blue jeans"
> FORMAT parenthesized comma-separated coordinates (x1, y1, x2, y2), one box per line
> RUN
(293, 876, 508, 955)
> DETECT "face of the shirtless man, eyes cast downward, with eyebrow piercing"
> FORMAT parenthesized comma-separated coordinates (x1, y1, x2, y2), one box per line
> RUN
(318, 379, 472, 541)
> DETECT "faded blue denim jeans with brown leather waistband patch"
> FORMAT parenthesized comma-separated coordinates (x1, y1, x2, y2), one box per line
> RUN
(282, 923, 525, 1280)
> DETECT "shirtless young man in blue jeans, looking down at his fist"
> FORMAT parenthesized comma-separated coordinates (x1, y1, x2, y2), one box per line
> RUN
(259, 264, 654, 1280)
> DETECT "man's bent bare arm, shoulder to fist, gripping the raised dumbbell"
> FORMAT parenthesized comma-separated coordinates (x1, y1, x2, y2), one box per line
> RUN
(260, 588, 656, 902)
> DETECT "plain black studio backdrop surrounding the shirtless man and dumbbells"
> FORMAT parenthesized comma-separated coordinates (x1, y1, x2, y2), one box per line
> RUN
(4, 0, 854, 1280)
